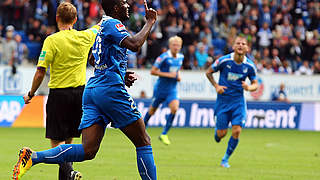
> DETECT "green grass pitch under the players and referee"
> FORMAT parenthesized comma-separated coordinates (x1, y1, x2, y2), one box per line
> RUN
(0, 128, 320, 180)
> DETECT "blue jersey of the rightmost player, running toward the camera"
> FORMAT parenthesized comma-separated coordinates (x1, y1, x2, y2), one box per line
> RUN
(212, 53, 257, 100)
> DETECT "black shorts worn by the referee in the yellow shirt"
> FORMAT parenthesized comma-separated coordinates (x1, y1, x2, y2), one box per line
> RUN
(46, 86, 84, 141)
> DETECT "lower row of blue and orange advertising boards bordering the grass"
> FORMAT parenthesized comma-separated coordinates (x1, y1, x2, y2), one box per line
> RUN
(0, 95, 320, 131)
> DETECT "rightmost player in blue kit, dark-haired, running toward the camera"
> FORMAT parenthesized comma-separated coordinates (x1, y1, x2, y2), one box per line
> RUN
(206, 36, 258, 168)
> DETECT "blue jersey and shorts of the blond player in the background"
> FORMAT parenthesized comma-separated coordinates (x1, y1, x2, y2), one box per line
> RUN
(153, 50, 184, 93)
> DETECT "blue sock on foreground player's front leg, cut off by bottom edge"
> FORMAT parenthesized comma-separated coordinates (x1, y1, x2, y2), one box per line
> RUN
(136, 145, 157, 180)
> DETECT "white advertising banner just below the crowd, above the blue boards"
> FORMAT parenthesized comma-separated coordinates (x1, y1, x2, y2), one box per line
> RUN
(0, 66, 320, 102)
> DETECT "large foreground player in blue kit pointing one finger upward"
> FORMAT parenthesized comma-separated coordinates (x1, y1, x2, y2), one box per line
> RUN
(14, 0, 157, 180)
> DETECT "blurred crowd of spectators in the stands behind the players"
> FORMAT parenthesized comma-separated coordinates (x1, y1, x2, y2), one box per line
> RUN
(0, 0, 320, 75)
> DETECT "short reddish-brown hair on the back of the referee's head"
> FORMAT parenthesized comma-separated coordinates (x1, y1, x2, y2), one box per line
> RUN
(57, 2, 77, 24)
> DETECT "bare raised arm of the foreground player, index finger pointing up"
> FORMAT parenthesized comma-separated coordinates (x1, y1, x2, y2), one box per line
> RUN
(121, 0, 157, 52)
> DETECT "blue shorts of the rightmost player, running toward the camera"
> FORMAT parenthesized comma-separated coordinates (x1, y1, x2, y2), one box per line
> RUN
(214, 99, 247, 130)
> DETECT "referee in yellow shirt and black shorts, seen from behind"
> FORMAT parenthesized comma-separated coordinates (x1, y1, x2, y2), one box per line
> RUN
(23, 2, 100, 180)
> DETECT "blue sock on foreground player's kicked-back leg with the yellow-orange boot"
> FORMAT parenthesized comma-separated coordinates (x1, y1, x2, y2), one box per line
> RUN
(32, 144, 84, 165)
